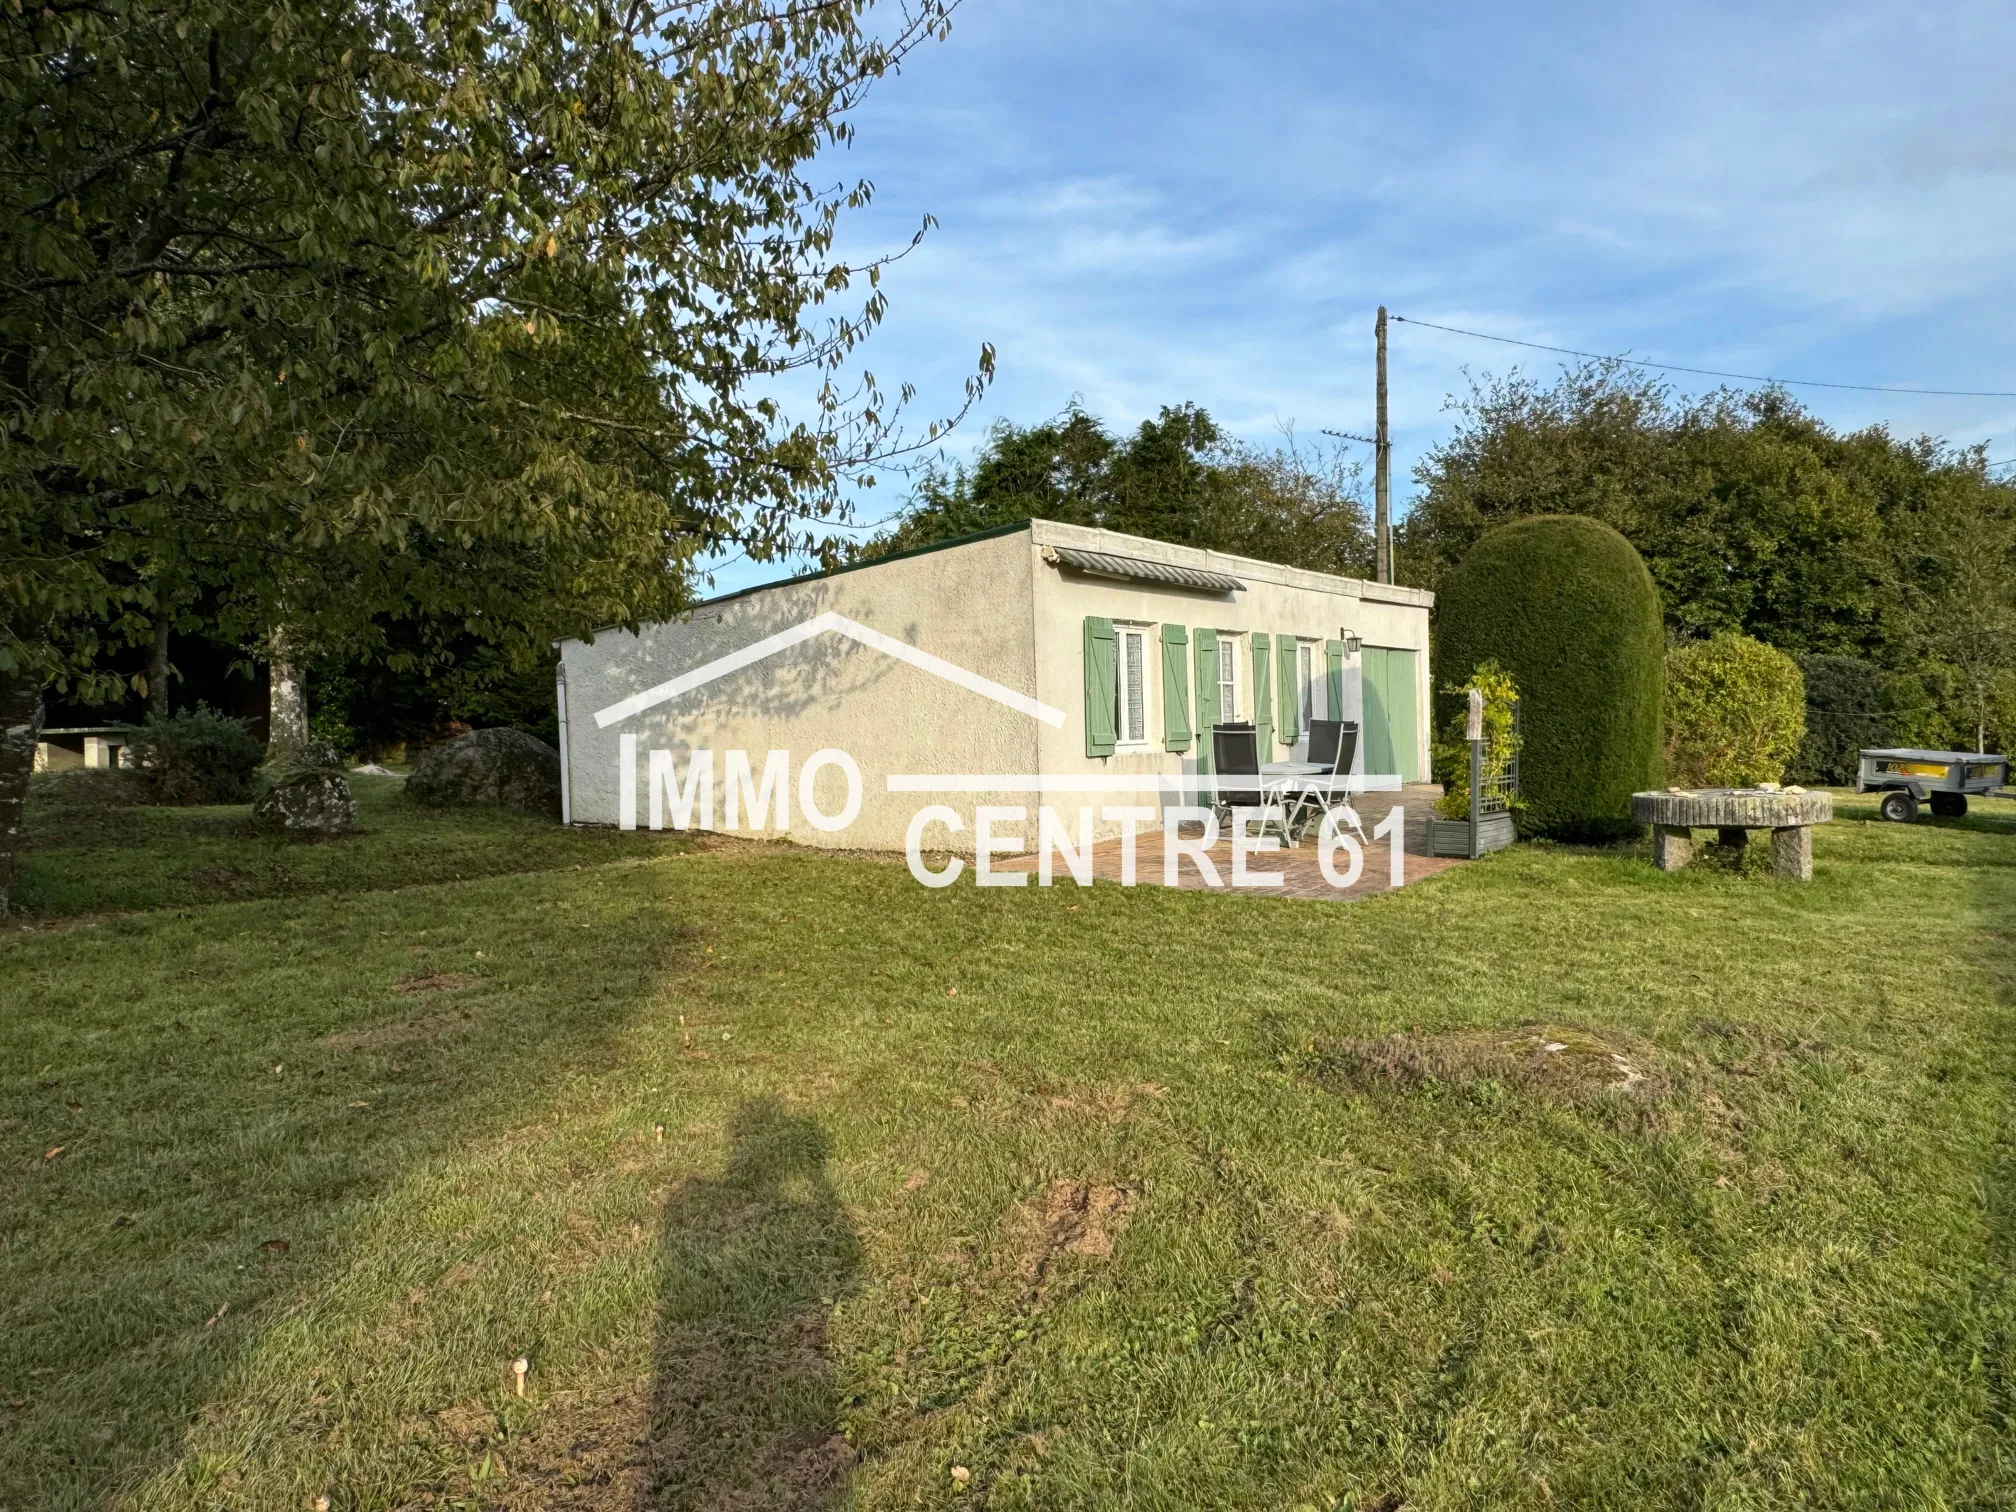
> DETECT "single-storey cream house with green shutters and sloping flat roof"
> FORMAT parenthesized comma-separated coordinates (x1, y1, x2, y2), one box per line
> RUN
(558, 520, 1433, 851)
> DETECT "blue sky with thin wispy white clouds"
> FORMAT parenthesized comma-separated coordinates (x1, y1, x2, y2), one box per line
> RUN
(716, 0, 2016, 591)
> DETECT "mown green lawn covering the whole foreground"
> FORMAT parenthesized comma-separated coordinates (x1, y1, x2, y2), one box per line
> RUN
(0, 778, 2016, 1512)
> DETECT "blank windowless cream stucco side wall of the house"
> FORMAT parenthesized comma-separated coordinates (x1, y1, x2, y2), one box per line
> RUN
(560, 530, 1068, 851)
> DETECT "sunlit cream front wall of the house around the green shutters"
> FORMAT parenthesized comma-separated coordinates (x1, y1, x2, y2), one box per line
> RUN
(1026, 520, 1433, 835)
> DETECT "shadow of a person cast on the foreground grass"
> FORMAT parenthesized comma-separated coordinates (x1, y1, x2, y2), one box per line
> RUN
(637, 1101, 861, 1512)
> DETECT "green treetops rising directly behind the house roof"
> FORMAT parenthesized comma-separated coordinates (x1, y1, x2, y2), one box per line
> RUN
(859, 405, 1371, 577)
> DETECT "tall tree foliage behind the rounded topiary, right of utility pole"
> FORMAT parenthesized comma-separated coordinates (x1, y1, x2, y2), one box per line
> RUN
(1399, 363, 2016, 746)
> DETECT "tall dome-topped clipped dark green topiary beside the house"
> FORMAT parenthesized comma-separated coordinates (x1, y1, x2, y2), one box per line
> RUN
(1435, 514, 1665, 841)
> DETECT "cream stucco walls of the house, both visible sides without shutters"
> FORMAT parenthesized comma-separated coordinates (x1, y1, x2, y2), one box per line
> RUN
(560, 520, 1433, 855)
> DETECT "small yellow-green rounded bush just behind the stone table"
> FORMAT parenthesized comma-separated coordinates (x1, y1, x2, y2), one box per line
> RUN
(1665, 633, 1806, 788)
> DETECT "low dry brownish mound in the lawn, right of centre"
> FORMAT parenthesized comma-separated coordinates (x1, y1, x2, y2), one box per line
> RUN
(1312, 1024, 1667, 1101)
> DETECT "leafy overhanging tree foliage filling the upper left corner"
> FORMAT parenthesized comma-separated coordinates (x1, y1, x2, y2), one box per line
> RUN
(0, 0, 990, 697)
